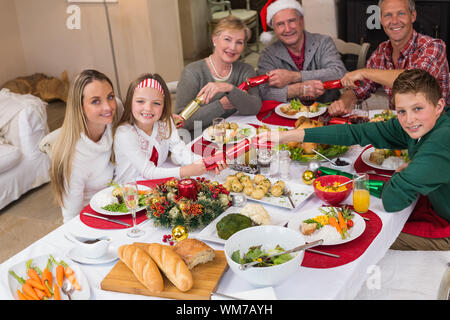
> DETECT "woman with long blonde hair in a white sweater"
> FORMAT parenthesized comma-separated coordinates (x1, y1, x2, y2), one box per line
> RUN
(50, 70, 118, 223)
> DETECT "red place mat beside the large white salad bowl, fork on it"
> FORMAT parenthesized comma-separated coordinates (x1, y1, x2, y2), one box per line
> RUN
(302, 205, 383, 269)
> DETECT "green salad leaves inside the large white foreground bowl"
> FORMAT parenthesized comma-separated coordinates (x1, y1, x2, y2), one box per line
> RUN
(231, 245, 293, 267)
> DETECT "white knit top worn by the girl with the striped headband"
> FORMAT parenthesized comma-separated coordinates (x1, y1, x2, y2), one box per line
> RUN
(114, 121, 201, 183)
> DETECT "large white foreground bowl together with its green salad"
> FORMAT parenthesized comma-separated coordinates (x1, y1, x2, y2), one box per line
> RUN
(224, 225, 305, 286)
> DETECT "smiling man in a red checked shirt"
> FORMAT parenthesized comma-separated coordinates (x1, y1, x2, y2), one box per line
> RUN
(328, 0, 450, 115)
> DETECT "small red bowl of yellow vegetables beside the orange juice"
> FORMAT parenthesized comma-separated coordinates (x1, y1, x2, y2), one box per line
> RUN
(313, 175, 352, 206)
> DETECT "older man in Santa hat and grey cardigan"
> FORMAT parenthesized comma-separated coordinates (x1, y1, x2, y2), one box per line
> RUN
(258, 0, 347, 102)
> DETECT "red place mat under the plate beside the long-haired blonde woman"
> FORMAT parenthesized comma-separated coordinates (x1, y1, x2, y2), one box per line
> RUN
(80, 177, 173, 230)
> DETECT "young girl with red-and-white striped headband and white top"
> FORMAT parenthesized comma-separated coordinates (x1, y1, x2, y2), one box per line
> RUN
(114, 74, 223, 182)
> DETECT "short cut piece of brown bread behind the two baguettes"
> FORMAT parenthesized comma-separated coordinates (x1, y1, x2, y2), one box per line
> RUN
(173, 239, 215, 269)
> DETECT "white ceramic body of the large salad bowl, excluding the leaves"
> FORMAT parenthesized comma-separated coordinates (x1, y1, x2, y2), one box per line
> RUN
(225, 226, 305, 286)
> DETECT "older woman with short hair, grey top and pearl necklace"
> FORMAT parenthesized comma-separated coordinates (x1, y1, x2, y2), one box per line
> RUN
(175, 15, 261, 131)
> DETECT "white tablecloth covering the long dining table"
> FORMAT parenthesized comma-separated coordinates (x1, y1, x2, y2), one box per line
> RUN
(0, 112, 414, 300)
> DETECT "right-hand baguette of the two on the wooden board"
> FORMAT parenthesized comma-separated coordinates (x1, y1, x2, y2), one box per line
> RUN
(147, 243, 194, 292)
